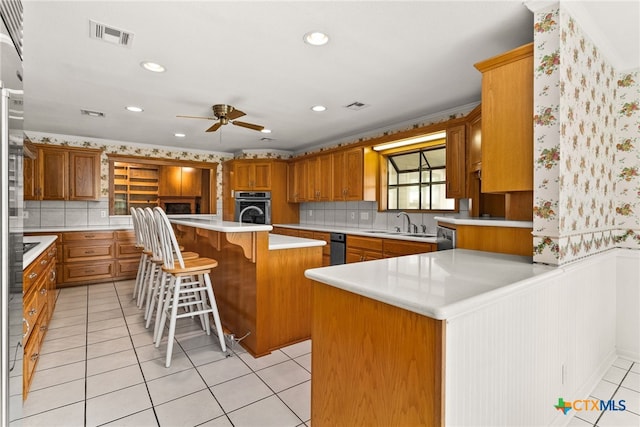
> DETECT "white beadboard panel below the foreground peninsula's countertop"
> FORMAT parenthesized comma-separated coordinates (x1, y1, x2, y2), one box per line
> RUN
(445, 250, 624, 427)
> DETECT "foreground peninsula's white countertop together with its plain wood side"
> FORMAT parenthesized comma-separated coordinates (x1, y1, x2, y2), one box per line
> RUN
(305, 249, 555, 427)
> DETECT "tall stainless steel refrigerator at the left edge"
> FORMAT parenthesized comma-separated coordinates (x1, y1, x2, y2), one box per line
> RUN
(0, 0, 23, 427)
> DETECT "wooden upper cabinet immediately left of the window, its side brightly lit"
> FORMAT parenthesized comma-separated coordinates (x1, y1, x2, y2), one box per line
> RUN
(332, 147, 378, 201)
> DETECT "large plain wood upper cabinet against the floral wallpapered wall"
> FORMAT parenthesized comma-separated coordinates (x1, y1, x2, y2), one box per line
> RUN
(475, 43, 533, 193)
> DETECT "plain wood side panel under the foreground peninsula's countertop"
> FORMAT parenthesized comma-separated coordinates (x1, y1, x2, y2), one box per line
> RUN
(311, 282, 445, 427)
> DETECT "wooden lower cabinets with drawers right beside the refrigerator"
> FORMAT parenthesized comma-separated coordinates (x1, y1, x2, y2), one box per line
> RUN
(22, 239, 57, 400)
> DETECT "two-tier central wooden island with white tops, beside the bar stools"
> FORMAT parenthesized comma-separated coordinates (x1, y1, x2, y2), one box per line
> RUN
(170, 218, 326, 357)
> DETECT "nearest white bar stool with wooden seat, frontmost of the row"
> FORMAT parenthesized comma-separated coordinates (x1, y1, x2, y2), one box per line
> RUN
(153, 207, 227, 368)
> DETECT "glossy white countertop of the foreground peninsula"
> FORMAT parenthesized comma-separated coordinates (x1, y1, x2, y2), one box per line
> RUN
(305, 249, 560, 320)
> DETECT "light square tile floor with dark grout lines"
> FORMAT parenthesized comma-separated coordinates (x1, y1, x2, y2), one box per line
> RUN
(11, 281, 640, 427)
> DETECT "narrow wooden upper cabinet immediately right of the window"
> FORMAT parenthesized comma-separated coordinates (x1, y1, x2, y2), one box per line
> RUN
(446, 123, 467, 199)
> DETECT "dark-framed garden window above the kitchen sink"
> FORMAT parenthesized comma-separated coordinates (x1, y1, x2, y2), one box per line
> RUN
(387, 144, 456, 211)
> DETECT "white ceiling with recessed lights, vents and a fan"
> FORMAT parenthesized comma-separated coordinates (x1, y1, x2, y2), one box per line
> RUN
(23, 0, 639, 152)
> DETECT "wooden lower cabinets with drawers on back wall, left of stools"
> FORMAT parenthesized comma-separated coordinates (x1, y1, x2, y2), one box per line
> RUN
(26, 230, 140, 288)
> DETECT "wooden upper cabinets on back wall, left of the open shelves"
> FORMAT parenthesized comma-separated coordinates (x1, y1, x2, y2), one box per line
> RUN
(24, 144, 102, 200)
